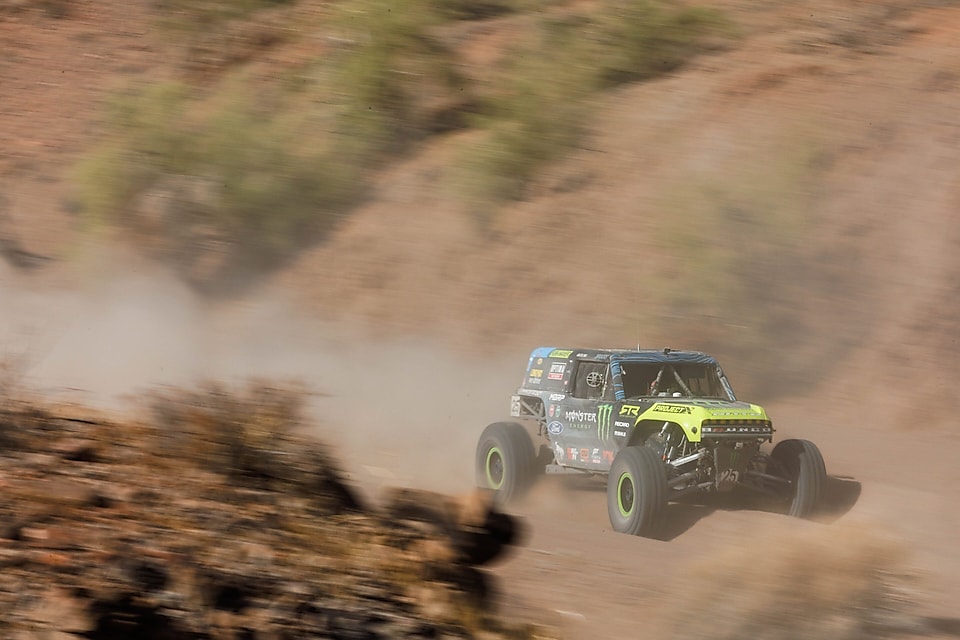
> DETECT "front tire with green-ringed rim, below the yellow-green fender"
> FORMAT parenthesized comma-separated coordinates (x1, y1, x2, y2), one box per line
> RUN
(607, 447, 667, 536)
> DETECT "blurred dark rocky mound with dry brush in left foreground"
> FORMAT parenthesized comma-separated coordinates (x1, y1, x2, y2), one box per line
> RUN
(0, 388, 533, 640)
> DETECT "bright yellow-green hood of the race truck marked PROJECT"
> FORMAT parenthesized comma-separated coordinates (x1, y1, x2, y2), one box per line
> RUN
(637, 398, 770, 442)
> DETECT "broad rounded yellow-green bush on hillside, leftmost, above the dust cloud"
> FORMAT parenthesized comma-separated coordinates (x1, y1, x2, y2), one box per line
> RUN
(77, 78, 362, 282)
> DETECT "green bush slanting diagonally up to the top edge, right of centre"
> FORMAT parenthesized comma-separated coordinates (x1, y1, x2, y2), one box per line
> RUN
(456, 0, 731, 216)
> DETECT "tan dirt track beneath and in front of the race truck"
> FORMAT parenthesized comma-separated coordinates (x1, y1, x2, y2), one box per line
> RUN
(324, 390, 960, 640)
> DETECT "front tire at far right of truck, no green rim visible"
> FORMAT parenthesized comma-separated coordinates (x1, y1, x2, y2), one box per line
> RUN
(770, 440, 827, 518)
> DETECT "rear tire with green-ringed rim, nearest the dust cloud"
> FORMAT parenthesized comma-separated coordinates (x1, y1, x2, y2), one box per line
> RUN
(476, 422, 536, 504)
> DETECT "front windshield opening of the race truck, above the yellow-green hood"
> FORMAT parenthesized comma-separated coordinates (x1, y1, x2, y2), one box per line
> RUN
(620, 362, 733, 400)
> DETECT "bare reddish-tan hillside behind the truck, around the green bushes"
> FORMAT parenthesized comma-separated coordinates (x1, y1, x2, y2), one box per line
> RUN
(0, 1, 960, 411)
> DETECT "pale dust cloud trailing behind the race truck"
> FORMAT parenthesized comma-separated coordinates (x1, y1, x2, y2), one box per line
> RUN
(0, 256, 525, 494)
